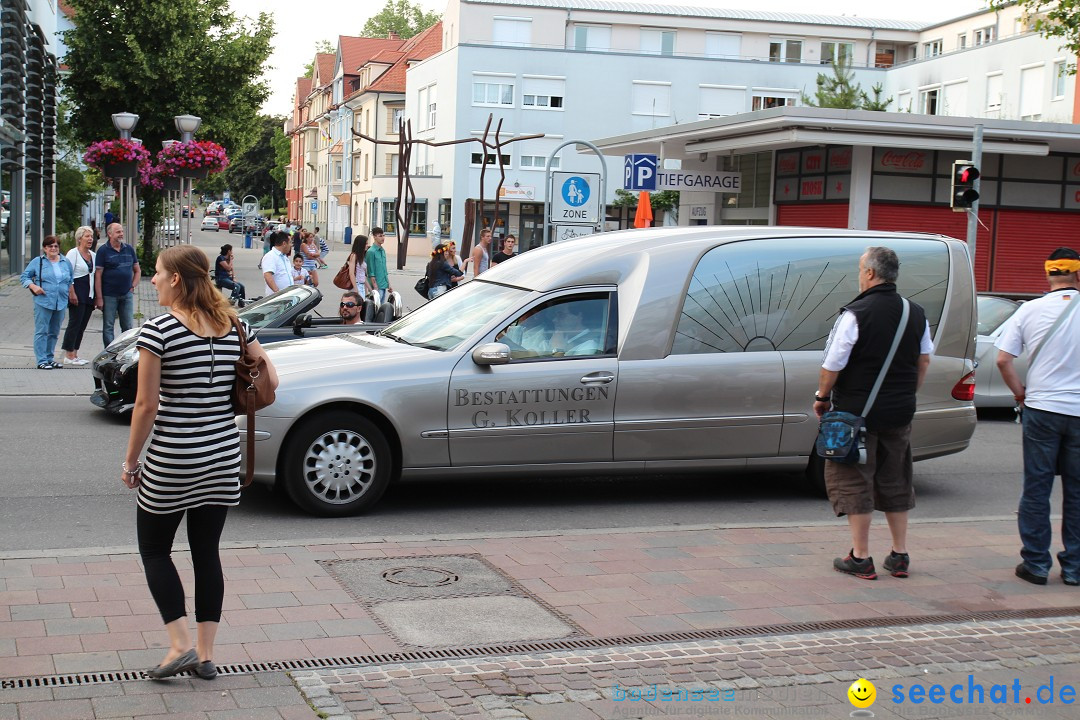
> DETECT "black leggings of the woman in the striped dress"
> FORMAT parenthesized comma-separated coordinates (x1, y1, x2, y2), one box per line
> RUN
(136, 505, 229, 625)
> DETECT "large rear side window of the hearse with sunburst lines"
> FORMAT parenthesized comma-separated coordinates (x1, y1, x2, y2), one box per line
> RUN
(672, 237, 949, 355)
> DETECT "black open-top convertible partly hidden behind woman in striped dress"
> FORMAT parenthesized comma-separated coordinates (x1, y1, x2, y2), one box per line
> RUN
(90, 285, 395, 413)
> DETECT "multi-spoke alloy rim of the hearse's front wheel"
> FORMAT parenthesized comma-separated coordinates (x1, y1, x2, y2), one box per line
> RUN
(303, 430, 377, 505)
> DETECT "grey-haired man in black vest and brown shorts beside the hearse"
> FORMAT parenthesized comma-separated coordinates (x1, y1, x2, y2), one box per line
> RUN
(813, 247, 933, 580)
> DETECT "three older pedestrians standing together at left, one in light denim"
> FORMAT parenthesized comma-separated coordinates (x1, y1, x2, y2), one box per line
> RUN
(21, 222, 141, 370)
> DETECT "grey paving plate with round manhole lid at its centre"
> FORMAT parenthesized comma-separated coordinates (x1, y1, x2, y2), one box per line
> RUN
(321, 555, 524, 604)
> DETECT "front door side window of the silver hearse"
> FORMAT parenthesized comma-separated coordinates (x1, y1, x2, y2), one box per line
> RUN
(495, 293, 615, 359)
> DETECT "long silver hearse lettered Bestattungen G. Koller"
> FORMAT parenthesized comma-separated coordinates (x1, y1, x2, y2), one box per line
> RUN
(247, 227, 975, 516)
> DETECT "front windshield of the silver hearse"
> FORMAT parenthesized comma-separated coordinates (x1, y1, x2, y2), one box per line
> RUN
(379, 281, 529, 350)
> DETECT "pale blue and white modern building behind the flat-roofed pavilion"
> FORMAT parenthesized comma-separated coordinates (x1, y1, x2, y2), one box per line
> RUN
(393, 0, 1075, 247)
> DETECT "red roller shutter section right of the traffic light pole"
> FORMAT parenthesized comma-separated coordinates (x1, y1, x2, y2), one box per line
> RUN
(994, 209, 1080, 294)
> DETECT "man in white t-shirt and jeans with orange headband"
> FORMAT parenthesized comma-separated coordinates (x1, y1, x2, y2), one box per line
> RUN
(995, 247, 1080, 585)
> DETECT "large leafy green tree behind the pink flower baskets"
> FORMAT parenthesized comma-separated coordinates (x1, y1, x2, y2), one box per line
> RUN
(64, 0, 273, 258)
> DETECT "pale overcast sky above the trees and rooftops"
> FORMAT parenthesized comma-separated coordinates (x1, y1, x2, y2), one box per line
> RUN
(230, 0, 987, 114)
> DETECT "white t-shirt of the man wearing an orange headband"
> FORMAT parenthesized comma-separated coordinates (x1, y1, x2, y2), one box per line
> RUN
(994, 288, 1080, 416)
